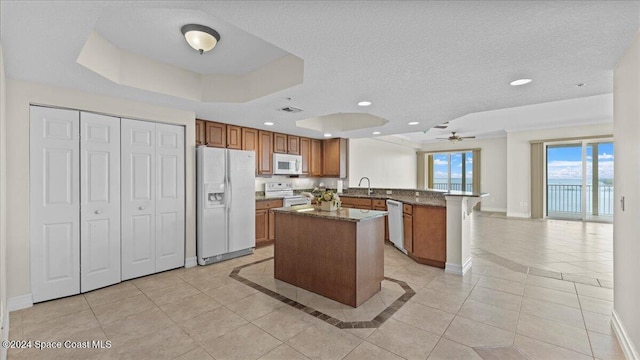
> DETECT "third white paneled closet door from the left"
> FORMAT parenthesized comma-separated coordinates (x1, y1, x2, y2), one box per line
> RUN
(121, 119, 156, 280)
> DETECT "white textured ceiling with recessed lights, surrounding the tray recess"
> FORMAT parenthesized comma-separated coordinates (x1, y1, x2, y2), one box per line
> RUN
(0, 0, 640, 141)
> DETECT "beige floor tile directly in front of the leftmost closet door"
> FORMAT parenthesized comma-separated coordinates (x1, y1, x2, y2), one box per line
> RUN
(19, 295, 89, 327)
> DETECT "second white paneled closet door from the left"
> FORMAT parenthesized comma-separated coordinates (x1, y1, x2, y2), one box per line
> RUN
(80, 112, 120, 292)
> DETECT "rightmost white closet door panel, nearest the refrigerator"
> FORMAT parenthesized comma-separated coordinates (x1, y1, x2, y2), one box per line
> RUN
(156, 124, 185, 272)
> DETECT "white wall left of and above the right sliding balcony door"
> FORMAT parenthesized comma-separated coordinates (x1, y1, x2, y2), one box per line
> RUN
(506, 123, 618, 217)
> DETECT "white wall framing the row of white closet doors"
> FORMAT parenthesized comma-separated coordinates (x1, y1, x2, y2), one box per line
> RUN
(2, 79, 196, 298)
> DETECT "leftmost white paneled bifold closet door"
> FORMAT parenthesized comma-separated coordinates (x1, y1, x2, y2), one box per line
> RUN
(29, 106, 80, 302)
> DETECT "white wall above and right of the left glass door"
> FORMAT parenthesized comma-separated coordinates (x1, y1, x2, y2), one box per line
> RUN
(422, 137, 507, 212)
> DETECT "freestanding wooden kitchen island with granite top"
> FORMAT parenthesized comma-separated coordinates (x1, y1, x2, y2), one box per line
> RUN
(273, 205, 387, 307)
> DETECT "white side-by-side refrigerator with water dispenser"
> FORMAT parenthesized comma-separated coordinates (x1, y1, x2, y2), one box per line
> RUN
(196, 146, 256, 265)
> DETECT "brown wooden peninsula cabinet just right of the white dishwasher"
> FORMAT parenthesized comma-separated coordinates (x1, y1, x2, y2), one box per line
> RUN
(403, 204, 447, 268)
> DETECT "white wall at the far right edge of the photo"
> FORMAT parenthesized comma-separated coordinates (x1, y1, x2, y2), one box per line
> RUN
(613, 30, 640, 359)
